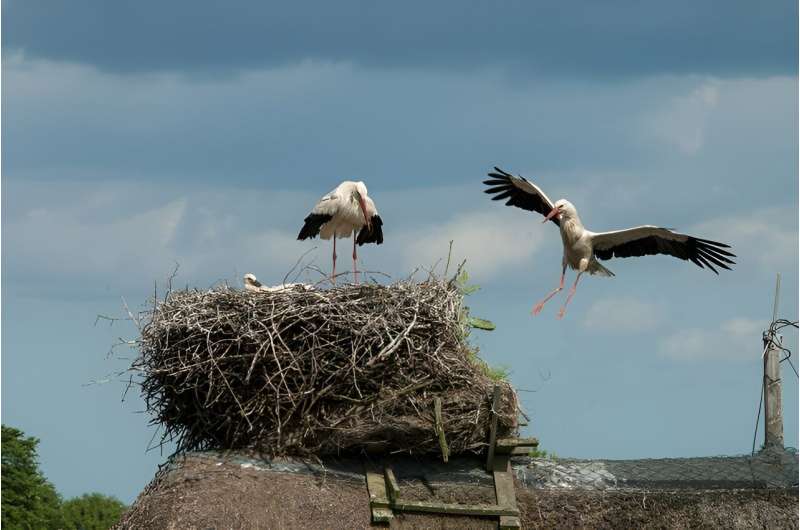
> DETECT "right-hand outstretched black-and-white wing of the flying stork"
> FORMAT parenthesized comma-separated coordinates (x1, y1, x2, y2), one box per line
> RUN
(591, 225, 736, 274)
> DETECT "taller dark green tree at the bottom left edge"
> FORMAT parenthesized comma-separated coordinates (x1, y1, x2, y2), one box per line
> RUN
(2, 425, 62, 530)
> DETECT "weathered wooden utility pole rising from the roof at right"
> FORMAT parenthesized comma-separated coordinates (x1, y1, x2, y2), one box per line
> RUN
(764, 273, 783, 450)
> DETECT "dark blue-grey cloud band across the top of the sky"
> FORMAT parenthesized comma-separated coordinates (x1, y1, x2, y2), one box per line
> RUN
(2, 0, 797, 76)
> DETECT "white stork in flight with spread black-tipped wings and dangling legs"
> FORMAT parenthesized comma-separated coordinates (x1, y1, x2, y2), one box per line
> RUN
(483, 167, 736, 318)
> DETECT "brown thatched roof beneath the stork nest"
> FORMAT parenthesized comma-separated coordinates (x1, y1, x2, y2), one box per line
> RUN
(117, 454, 798, 530)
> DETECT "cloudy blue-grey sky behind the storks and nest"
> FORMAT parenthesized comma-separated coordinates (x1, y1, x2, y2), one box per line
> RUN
(2, 0, 798, 502)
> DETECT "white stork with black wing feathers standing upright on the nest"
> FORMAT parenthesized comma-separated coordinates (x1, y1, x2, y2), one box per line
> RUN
(297, 180, 383, 283)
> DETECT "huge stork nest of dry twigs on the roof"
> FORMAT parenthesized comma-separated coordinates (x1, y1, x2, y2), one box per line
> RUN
(132, 278, 517, 455)
